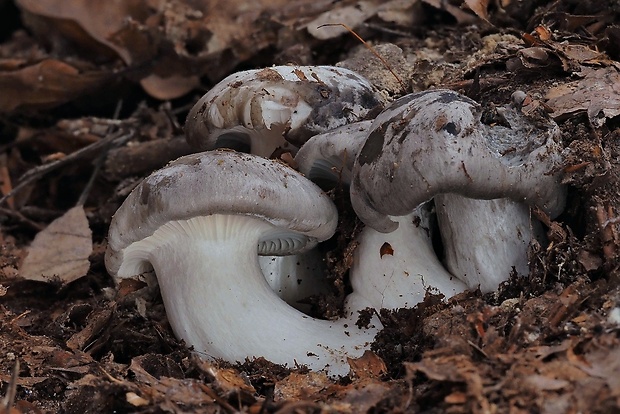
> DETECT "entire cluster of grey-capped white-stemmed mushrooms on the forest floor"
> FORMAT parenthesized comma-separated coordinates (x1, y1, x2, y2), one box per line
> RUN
(106, 66, 565, 375)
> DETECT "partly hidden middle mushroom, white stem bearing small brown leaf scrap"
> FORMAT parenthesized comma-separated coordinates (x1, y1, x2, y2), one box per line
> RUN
(295, 121, 466, 310)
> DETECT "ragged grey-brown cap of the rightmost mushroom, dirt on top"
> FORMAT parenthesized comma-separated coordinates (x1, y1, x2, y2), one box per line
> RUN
(351, 90, 565, 232)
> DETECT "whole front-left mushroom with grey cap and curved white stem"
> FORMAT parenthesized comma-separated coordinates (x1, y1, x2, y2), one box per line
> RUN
(105, 151, 381, 375)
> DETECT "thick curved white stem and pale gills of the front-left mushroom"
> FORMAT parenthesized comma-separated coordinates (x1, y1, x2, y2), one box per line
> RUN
(119, 214, 380, 375)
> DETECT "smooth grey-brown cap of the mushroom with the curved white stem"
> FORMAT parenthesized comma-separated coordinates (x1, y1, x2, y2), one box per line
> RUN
(106, 151, 338, 276)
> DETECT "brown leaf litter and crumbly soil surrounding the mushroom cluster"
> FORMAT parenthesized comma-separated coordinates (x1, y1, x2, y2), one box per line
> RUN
(0, 0, 620, 414)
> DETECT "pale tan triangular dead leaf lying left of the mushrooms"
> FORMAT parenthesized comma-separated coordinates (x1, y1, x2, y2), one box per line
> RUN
(19, 206, 93, 285)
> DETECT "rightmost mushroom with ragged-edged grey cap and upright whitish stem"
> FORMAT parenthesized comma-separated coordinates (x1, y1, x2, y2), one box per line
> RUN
(351, 90, 565, 291)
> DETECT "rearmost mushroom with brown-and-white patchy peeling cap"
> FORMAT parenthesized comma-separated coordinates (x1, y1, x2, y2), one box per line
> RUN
(185, 66, 381, 157)
